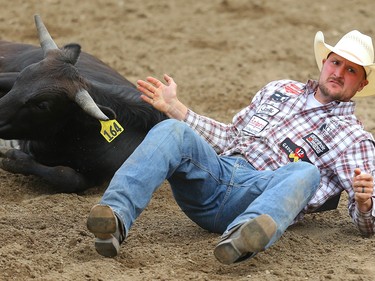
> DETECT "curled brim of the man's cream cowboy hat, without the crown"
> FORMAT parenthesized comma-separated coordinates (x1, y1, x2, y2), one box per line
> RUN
(314, 31, 375, 97)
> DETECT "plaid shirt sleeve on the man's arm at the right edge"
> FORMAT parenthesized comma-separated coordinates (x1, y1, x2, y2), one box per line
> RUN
(335, 140, 375, 236)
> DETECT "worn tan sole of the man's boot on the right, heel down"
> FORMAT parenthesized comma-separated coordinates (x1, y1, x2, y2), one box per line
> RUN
(214, 215, 277, 264)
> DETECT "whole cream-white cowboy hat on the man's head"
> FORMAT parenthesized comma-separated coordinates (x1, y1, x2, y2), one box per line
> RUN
(314, 30, 375, 97)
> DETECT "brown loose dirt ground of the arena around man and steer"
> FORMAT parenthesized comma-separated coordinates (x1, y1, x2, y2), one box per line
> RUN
(0, 0, 375, 281)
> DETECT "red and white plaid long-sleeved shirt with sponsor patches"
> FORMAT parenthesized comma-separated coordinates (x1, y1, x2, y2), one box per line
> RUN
(184, 80, 375, 236)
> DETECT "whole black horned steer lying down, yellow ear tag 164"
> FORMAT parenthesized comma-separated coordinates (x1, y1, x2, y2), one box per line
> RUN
(0, 16, 166, 192)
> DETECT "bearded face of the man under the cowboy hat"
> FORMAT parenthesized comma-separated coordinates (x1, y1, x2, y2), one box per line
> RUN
(315, 53, 368, 103)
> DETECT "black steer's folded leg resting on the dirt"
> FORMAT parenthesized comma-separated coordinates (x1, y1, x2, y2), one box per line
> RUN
(0, 147, 90, 193)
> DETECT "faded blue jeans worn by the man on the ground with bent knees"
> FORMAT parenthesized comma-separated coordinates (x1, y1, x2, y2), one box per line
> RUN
(100, 120, 320, 248)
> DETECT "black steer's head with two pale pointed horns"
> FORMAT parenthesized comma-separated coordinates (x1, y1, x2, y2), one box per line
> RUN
(0, 15, 113, 139)
